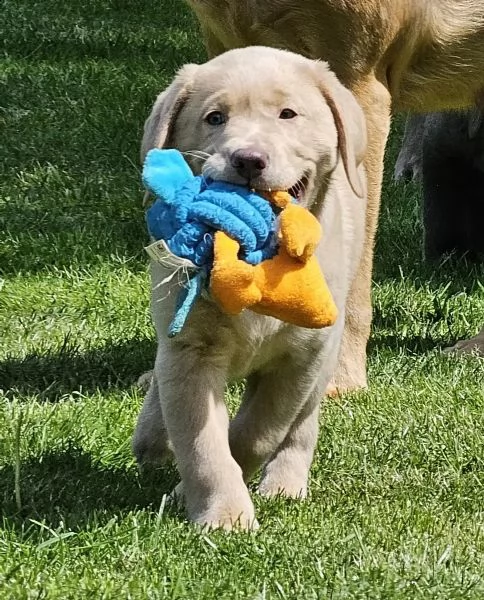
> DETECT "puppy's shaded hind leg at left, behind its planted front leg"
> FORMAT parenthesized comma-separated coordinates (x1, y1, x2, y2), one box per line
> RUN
(132, 372, 173, 465)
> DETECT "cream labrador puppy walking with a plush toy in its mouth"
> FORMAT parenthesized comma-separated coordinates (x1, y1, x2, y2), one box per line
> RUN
(133, 47, 366, 529)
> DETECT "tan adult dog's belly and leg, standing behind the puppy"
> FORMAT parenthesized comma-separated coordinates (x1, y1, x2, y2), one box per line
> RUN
(187, 0, 484, 389)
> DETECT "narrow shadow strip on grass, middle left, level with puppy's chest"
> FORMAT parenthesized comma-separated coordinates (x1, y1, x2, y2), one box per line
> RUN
(0, 339, 156, 402)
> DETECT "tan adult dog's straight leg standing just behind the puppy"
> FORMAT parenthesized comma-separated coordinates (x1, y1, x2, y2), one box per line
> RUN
(328, 79, 391, 393)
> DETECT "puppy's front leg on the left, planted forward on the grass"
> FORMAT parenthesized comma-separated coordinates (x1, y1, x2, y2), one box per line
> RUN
(155, 342, 257, 529)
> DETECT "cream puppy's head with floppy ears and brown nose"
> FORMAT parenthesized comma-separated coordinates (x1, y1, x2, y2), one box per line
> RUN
(141, 47, 366, 206)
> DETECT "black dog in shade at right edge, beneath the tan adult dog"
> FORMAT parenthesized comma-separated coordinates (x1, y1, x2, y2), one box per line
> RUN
(395, 107, 484, 260)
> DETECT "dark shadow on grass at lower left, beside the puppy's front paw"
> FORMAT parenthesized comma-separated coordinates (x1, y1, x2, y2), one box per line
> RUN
(0, 448, 178, 529)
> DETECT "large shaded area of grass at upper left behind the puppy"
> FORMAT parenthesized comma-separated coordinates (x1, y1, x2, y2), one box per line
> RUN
(0, 0, 204, 275)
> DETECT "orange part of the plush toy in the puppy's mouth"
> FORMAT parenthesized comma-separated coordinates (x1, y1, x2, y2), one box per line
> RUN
(210, 192, 338, 328)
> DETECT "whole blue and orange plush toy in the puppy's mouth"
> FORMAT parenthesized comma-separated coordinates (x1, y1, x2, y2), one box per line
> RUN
(143, 149, 337, 336)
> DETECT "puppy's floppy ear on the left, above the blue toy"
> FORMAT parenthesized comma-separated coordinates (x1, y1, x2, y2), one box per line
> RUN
(141, 65, 198, 162)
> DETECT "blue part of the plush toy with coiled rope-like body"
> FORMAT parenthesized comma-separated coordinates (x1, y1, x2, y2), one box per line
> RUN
(143, 149, 277, 337)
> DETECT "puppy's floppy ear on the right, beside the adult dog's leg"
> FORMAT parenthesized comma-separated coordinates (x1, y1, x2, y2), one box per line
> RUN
(317, 62, 366, 198)
